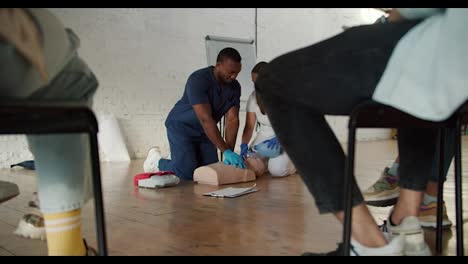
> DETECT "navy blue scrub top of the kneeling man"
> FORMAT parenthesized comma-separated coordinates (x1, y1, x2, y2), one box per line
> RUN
(165, 66, 241, 137)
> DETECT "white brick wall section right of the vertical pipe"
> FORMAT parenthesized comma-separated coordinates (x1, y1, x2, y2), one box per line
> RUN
(257, 8, 390, 141)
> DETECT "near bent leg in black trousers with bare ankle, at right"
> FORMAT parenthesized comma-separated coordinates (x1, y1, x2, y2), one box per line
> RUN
(256, 23, 420, 254)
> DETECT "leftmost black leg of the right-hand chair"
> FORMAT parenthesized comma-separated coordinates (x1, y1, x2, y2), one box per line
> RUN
(343, 122, 356, 256)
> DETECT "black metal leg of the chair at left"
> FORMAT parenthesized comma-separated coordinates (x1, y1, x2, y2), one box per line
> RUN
(89, 133, 107, 256)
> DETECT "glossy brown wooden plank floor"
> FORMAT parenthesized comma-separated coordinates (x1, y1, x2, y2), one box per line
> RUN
(0, 138, 468, 256)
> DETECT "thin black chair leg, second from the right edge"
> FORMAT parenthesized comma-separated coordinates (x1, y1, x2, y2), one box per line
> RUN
(436, 128, 446, 254)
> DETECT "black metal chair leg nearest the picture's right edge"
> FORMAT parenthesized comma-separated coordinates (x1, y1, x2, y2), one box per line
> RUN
(455, 118, 464, 256)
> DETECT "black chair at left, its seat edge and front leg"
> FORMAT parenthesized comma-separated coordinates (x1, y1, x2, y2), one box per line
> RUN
(0, 100, 107, 256)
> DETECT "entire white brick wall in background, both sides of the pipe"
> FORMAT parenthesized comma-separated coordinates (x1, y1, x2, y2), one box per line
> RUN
(0, 8, 388, 167)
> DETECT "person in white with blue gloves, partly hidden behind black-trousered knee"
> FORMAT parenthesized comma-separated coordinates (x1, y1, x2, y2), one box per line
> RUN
(241, 61, 296, 177)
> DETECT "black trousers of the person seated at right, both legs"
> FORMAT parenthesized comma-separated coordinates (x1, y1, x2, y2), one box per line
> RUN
(252, 21, 437, 213)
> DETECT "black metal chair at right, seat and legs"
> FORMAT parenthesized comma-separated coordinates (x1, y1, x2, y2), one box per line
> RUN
(343, 101, 468, 256)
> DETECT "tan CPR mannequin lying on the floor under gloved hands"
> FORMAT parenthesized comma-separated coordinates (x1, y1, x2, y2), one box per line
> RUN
(193, 158, 266, 185)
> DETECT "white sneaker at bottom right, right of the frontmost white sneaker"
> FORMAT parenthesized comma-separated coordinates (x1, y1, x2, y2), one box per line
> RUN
(381, 214, 432, 256)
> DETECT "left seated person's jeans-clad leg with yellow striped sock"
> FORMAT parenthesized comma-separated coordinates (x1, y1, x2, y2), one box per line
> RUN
(0, 10, 97, 255)
